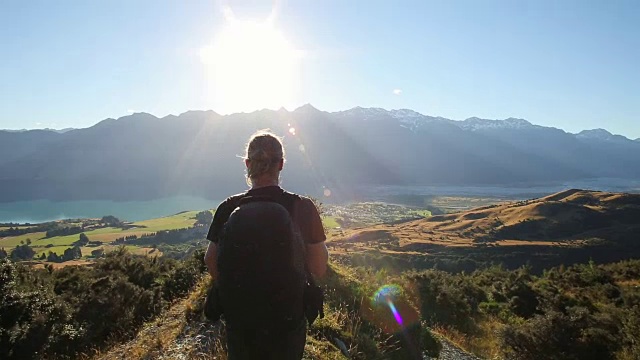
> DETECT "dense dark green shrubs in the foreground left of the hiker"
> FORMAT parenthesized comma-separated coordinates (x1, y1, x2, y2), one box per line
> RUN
(0, 249, 204, 359)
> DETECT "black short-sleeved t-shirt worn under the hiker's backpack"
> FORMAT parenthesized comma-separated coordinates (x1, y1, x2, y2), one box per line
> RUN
(207, 185, 326, 244)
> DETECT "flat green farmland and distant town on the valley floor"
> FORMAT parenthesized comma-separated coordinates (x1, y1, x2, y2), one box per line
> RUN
(0, 203, 438, 267)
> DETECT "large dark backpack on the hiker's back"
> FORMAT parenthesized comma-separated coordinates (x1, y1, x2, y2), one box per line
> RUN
(217, 192, 307, 330)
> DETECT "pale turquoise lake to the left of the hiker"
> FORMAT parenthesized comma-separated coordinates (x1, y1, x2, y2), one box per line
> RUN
(0, 196, 220, 223)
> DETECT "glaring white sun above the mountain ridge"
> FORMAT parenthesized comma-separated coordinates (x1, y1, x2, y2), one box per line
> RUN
(200, 11, 299, 113)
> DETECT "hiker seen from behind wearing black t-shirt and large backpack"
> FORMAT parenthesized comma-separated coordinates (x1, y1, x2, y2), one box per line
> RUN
(205, 130, 328, 360)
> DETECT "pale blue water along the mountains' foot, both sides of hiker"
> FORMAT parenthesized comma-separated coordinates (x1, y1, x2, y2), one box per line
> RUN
(0, 178, 640, 223)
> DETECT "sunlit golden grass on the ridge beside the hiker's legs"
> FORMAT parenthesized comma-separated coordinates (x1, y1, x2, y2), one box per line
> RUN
(92, 263, 442, 360)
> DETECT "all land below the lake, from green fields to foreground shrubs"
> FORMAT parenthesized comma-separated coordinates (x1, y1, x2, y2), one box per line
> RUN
(0, 189, 640, 360)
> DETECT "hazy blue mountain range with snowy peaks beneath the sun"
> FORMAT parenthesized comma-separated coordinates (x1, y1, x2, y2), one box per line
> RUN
(0, 105, 640, 202)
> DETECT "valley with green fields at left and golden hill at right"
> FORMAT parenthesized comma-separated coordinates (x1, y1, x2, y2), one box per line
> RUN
(0, 190, 640, 271)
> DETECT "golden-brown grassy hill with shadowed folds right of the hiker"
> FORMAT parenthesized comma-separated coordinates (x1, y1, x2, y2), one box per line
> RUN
(330, 190, 640, 270)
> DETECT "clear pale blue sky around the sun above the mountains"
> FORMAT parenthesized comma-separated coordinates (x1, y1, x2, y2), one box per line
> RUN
(0, 0, 640, 138)
